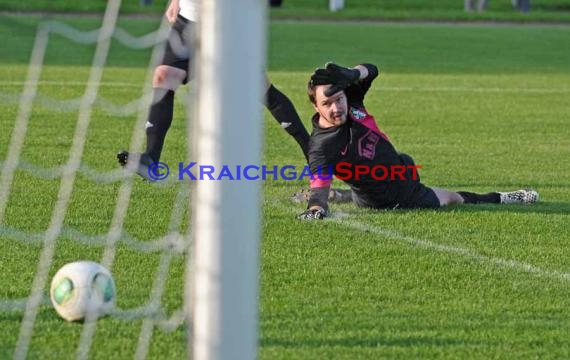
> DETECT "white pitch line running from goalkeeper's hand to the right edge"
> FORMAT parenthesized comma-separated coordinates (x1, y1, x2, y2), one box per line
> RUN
(333, 217, 570, 281)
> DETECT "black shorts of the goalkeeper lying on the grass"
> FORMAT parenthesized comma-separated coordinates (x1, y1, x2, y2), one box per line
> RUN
(352, 153, 441, 209)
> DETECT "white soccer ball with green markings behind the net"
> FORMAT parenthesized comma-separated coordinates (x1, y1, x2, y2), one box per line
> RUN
(50, 261, 116, 321)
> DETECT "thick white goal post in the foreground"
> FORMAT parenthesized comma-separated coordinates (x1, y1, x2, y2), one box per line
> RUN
(186, 0, 267, 360)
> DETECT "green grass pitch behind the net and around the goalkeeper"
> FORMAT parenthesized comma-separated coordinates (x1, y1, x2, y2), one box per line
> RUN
(0, 16, 570, 359)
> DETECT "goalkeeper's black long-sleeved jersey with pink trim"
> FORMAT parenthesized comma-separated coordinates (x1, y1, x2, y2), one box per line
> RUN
(309, 64, 412, 207)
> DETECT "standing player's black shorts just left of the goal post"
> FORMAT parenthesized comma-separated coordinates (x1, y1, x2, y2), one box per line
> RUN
(160, 15, 194, 84)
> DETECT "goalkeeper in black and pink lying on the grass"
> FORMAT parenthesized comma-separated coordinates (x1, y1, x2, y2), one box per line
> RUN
(299, 63, 538, 220)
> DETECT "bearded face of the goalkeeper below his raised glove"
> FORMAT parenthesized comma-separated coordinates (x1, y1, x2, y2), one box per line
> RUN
(313, 85, 348, 128)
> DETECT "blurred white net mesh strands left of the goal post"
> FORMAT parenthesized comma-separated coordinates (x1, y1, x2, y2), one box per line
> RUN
(0, 0, 190, 359)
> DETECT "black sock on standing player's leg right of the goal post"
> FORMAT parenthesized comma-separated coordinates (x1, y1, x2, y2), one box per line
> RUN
(265, 85, 309, 161)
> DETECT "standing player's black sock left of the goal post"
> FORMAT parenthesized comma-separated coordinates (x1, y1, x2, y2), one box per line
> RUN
(145, 88, 174, 161)
